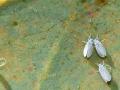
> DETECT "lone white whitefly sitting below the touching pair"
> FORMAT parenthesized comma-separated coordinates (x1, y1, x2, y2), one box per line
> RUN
(98, 63, 111, 83)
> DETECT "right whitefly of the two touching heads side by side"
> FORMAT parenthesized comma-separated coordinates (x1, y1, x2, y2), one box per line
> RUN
(93, 37, 106, 58)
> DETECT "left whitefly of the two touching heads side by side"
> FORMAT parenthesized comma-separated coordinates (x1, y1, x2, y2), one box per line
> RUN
(83, 36, 93, 58)
